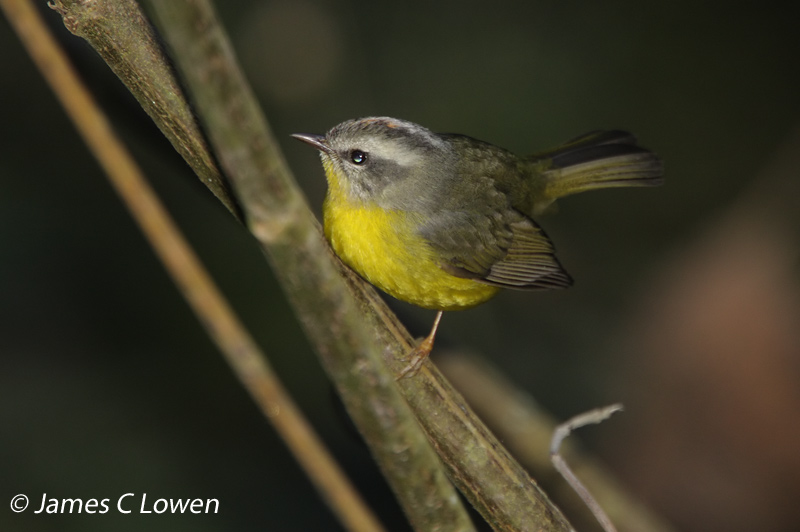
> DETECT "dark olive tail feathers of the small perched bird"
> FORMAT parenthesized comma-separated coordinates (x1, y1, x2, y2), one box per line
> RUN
(531, 131, 664, 212)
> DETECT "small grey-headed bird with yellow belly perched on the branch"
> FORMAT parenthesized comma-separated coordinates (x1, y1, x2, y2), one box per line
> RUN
(292, 117, 663, 377)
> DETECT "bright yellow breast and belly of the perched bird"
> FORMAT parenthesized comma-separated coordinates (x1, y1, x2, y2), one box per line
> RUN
(324, 196, 499, 310)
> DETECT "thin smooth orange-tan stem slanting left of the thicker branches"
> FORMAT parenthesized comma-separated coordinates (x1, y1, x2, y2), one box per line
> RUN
(0, 0, 382, 532)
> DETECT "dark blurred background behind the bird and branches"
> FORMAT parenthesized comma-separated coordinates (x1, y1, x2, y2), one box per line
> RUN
(0, 0, 800, 532)
